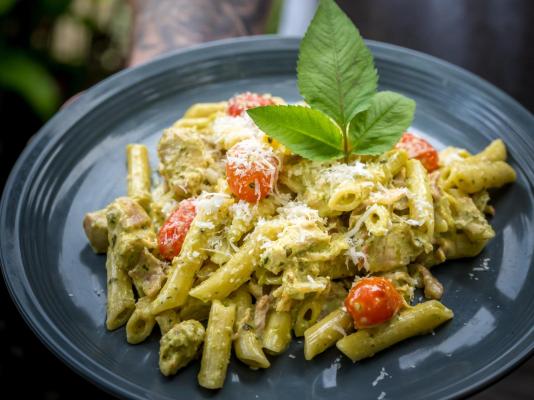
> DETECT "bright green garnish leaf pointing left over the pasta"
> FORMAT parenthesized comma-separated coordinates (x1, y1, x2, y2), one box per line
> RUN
(247, 106, 343, 161)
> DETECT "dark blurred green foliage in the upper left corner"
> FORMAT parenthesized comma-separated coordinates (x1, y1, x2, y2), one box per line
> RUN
(0, 0, 132, 121)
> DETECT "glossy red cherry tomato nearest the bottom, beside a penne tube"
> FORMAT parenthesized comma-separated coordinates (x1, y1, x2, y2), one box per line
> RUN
(345, 277, 403, 329)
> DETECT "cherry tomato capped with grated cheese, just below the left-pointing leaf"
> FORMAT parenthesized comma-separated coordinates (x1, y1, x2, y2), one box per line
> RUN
(226, 139, 278, 203)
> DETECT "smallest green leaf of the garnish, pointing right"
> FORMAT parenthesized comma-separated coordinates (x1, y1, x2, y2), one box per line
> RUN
(349, 92, 415, 155)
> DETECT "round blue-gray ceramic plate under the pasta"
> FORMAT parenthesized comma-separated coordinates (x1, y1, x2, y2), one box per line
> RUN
(0, 37, 534, 400)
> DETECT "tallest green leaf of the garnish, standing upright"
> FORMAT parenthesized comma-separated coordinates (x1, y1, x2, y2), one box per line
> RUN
(297, 0, 377, 130)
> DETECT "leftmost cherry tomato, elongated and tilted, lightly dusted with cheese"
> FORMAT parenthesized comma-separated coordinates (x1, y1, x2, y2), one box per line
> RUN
(158, 200, 196, 260)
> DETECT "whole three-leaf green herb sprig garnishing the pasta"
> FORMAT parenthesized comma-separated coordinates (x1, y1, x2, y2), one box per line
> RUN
(247, 0, 415, 161)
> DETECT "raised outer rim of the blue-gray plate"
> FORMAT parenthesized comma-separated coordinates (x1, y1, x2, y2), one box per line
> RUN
(0, 35, 534, 399)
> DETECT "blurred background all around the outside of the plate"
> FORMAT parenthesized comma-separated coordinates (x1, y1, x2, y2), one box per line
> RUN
(0, 0, 534, 400)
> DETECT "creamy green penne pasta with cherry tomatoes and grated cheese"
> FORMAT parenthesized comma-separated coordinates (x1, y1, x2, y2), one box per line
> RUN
(83, 93, 516, 389)
